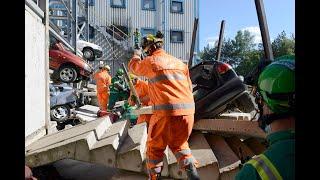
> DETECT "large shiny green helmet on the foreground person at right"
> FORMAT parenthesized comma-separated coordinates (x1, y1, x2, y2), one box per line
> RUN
(258, 56, 295, 114)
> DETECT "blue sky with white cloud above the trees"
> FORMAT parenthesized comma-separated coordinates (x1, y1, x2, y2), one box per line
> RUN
(199, 0, 295, 50)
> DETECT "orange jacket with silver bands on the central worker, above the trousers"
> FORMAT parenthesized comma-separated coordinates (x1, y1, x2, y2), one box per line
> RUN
(129, 49, 195, 116)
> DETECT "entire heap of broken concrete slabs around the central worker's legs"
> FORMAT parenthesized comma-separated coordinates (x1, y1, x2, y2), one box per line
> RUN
(26, 105, 265, 180)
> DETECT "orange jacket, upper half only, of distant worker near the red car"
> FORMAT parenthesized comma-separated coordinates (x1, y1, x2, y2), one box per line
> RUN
(94, 70, 111, 92)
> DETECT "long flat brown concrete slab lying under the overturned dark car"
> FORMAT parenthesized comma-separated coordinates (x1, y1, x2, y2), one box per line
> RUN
(193, 119, 266, 138)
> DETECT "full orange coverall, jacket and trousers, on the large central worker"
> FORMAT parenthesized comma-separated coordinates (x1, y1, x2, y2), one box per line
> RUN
(129, 49, 197, 179)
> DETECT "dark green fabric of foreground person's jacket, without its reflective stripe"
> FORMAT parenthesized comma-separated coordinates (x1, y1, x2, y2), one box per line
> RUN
(236, 131, 295, 180)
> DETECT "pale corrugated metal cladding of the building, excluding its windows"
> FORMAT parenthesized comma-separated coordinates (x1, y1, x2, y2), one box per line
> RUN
(89, 0, 199, 61)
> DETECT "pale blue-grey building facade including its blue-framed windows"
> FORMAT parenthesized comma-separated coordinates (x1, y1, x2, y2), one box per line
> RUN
(88, 0, 199, 63)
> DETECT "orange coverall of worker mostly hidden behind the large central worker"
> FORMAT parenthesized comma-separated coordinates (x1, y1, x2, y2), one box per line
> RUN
(129, 79, 152, 124)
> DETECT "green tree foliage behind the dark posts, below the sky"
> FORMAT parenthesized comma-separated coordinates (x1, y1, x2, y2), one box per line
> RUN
(200, 30, 295, 76)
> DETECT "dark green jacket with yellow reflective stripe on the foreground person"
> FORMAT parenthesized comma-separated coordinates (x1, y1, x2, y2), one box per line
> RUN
(235, 129, 295, 180)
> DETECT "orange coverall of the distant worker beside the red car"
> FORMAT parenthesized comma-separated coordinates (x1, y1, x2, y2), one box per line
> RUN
(94, 70, 111, 111)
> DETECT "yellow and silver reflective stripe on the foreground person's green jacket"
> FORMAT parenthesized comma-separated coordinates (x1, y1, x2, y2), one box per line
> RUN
(247, 154, 282, 180)
